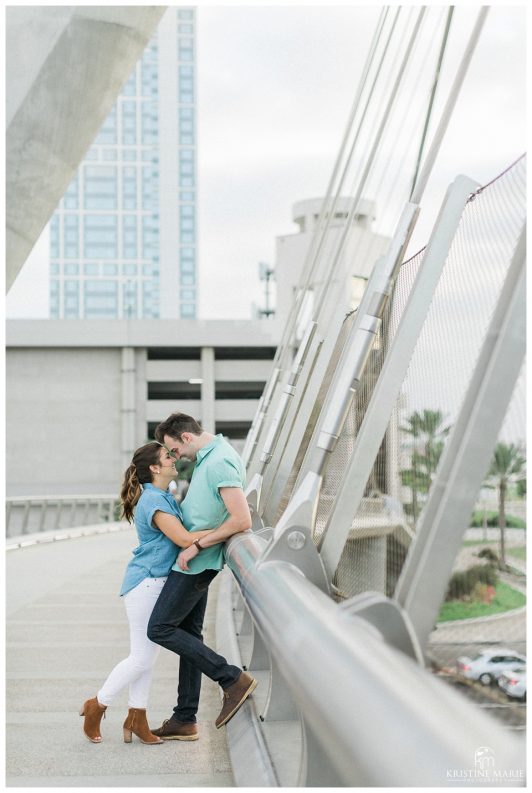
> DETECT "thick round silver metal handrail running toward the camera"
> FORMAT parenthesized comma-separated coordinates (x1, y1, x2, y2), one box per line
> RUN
(226, 532, 524, 787)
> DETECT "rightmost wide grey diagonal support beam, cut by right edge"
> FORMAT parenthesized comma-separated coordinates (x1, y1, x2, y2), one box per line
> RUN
(395, 221, 526, 648)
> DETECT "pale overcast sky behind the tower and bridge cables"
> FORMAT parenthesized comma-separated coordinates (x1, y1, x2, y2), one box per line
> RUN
(7, 3, 526, 318)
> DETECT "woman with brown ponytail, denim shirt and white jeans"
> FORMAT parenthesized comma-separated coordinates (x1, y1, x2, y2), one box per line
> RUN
(80, 442, 209, 744)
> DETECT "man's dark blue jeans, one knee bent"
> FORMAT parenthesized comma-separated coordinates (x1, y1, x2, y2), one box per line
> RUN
(148, 570, 242, 723)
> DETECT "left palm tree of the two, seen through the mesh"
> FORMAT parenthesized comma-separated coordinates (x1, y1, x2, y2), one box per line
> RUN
(401, 409, 450, 523)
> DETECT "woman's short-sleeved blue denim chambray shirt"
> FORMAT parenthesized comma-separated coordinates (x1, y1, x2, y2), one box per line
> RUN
(120, 483, 183, 596)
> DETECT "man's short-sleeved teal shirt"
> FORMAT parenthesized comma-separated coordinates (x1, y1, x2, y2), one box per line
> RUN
(172, 435, 246, 574)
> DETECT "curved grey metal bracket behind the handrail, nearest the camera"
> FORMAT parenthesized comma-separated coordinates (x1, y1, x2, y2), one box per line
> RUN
(338, 592, 424, 665)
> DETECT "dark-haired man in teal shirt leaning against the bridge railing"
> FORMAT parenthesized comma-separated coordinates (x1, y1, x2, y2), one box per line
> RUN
(148, 413, 257, 741)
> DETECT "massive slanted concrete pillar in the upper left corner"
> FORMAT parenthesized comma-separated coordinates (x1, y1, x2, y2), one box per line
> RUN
(6, 5, 166, 290)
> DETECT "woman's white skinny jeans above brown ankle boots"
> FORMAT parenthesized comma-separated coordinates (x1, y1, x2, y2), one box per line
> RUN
(97, 577, 166, 709)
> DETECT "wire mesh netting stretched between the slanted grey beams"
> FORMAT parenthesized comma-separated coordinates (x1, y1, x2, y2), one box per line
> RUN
(314, 157, 526, 724)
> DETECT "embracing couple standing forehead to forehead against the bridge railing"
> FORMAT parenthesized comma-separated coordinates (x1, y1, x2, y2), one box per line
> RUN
(80, 413, 257, 745)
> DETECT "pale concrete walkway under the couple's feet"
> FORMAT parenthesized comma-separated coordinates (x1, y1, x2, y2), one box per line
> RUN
(6, 528, 234, 788)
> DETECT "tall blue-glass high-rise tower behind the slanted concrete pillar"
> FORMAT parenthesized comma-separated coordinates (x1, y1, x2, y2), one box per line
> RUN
(50, 6, 197, 319)
